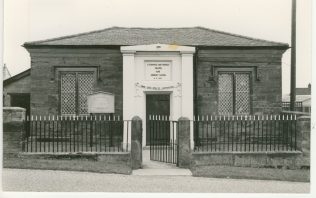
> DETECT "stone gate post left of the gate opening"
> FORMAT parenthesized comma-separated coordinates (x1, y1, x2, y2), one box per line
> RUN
(131, 116, 143, 170)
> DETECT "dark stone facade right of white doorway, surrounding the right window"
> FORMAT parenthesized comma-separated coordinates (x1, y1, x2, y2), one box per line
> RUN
(195, 48, 284, 115)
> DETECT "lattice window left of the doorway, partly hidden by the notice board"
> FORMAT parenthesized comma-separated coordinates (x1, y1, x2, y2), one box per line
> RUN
(60, 72, 95, 115)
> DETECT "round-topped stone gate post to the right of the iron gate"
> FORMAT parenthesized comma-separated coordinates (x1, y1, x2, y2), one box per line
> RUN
(178, 117, 191, 168)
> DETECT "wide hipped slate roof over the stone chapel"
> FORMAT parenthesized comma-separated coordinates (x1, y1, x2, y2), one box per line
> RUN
(24, 27, 288, 48)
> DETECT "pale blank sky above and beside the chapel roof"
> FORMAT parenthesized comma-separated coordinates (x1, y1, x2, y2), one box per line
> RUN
(4, 0, 312, 94)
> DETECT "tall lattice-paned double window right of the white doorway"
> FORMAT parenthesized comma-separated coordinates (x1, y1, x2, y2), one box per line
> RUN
(218, 72, 250, 115)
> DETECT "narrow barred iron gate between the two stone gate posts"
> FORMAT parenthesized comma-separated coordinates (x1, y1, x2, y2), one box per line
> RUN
(147, 115, 179, 166)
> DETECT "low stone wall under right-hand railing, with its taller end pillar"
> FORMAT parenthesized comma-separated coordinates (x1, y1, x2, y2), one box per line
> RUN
(191, 116, 311, 176)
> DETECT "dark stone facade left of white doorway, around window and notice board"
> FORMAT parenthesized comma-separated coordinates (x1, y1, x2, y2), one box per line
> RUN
(28, 47, 123, 115)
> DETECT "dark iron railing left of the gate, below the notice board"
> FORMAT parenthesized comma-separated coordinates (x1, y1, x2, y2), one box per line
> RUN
(22, 116, 131, 152)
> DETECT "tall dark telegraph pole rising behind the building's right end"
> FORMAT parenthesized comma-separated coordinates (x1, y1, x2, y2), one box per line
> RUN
(290, 0, 296, 111)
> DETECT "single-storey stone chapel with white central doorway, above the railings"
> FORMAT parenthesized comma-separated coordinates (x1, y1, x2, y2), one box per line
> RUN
(5, 27, 289, 145)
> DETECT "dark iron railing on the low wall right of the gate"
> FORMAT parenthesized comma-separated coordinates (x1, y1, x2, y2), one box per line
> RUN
(193, 115, 297, 152)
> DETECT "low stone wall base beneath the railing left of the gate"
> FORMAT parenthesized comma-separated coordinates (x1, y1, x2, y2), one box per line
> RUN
(3, 152, 132, 174)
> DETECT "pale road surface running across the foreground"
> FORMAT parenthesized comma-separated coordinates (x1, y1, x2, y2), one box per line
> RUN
(2, 169, 310, 193)
